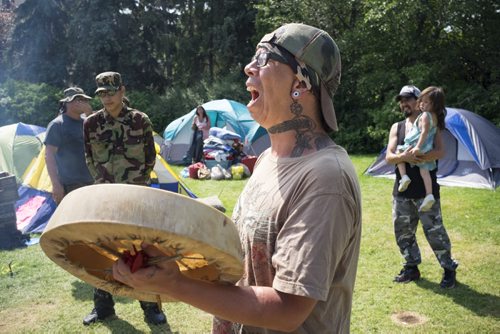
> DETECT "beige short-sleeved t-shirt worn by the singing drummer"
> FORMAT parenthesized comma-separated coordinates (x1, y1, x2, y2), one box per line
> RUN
(213, 145, 361, 333)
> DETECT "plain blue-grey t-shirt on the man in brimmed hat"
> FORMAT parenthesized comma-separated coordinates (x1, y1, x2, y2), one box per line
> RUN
(44, 114, 94, 185)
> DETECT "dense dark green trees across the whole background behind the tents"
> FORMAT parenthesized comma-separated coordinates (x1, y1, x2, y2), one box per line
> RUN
(0, 0, 500, 152)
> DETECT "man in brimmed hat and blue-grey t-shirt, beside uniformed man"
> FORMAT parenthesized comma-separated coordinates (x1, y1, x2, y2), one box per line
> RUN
(44, 87, 94, 203)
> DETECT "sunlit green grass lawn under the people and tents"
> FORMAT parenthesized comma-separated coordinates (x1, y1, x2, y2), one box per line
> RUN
(0, 155, 500, 333)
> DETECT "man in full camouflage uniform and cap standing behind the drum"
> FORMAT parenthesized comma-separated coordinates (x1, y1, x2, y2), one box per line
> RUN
(83, 72, 166, 325)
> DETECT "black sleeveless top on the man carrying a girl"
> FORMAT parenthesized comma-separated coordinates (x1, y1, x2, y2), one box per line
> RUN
(392, 121, 439, 199)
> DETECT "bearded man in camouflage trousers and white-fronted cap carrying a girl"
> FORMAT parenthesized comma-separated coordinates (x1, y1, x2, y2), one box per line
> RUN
(386, 86, 458, 288)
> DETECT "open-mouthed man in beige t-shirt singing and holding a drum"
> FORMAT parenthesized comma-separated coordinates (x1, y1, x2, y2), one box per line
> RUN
(113, 23, 361, 333)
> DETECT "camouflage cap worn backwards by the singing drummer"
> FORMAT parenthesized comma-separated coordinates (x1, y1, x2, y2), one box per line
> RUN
(257, 23, 341, 131)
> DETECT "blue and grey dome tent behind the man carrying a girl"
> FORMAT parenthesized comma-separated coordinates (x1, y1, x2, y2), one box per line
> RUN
(365, 108, 500, 189)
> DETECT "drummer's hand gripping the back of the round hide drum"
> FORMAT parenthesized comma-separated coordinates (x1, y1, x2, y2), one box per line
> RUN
(113, 243, 182, 293)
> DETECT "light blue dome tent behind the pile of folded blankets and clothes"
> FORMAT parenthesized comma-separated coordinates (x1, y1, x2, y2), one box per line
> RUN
(162, 99, 270, 164)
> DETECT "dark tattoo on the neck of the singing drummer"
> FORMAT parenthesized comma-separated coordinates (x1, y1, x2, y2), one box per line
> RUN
(267, 100, 331, 157)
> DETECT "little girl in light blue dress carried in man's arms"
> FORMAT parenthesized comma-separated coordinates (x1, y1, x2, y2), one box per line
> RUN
(397, 86, 445, 211)
